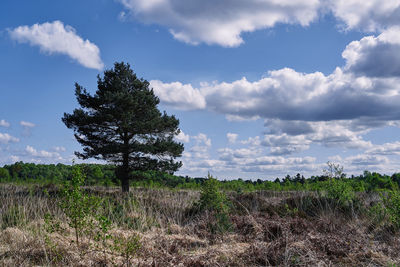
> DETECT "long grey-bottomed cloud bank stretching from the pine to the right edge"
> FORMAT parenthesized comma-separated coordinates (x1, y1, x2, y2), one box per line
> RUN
(150, 27, 400, 125)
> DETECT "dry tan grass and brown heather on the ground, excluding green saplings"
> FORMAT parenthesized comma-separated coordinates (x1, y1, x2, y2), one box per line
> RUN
(0, 185, 400, 266)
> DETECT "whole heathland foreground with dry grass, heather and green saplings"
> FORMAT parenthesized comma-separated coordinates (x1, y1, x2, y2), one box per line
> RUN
(0, 166, 400, 266)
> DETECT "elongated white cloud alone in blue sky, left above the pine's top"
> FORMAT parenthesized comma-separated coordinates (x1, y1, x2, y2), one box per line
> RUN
(9, 20, 104, 70)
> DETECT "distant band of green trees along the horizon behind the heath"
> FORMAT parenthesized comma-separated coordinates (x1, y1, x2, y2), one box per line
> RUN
(0, 162, 400, 192)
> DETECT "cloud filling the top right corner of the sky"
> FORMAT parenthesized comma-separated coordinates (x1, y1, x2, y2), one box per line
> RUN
(326, 0, 400, 32)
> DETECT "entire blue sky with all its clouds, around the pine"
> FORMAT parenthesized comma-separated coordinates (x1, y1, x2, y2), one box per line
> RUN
(0, 0, 400, 179)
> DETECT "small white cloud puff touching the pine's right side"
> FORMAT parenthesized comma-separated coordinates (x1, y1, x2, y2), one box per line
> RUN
(150, 80, 206, 110)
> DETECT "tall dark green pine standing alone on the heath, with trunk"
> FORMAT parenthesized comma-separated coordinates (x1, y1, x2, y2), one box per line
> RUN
(62, 62, 183, 192)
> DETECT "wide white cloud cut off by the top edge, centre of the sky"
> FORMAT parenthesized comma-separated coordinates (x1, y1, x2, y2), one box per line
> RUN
(120, 0, 320, 47)
